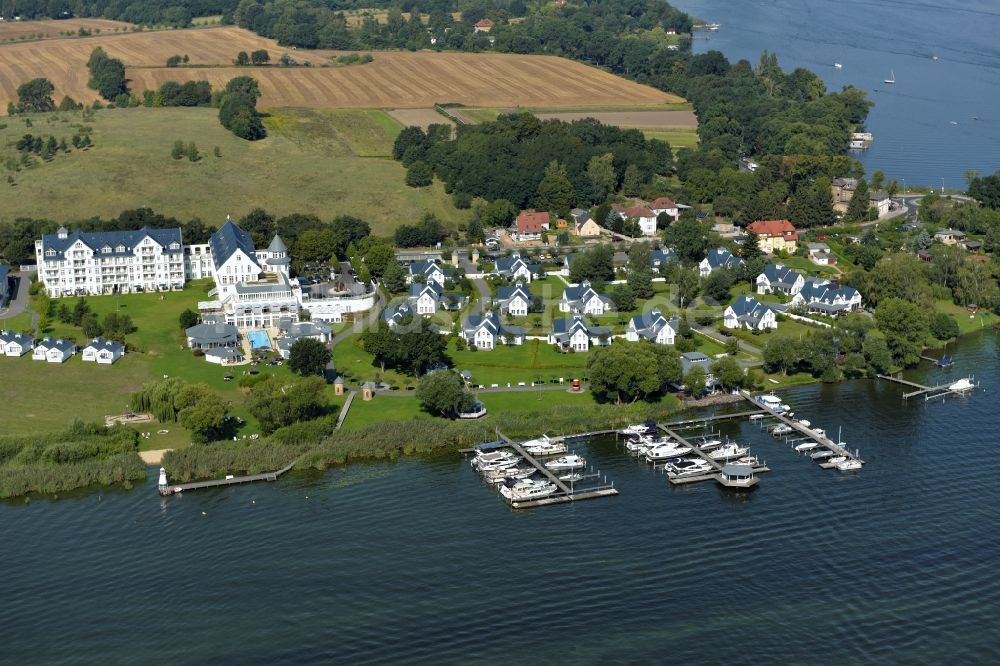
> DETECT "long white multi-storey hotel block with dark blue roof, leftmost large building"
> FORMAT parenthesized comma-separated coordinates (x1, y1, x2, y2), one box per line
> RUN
(35, 227, 204, 297)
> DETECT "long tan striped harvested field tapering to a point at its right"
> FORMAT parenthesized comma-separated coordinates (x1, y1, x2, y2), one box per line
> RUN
(128, 52, 682, 109)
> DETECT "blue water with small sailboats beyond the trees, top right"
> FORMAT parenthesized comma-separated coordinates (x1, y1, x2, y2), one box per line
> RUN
(676, 0, 1000, 189)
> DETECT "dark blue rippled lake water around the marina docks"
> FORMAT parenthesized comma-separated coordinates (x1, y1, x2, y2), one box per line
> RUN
(0, 335, 1000, 664)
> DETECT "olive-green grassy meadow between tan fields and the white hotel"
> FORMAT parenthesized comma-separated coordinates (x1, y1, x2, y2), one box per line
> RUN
(0, 107, 468, 234)
